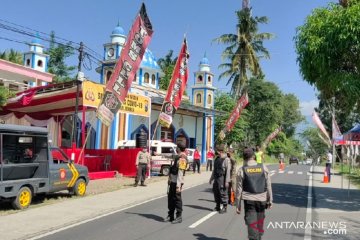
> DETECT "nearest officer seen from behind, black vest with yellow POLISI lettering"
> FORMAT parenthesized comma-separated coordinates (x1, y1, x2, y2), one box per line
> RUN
(236, 148, 273, 240)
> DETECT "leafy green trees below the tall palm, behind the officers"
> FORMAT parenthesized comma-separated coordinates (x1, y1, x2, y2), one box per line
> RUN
(215, 75, 303, 156)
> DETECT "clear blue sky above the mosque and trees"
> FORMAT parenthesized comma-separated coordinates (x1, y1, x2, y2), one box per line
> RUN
(0, 0, 334, 114)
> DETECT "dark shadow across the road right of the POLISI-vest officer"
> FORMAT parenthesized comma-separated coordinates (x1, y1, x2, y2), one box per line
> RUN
(272, 183, 360, 212)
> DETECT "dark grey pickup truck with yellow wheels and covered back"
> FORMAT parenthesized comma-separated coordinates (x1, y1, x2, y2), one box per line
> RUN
(0, 124, 89, 209)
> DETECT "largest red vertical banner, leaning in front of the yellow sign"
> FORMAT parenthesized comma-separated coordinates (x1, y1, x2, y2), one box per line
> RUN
(96, 3, 153, 126)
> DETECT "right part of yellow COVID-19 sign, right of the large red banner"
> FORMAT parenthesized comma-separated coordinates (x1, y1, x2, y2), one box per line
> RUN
(119, 93, 151, 117)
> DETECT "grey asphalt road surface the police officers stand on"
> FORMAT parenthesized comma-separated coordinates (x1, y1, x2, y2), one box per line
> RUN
(38, 165, 310, 240)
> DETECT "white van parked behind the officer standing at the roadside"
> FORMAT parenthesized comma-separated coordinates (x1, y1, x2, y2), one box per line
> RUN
(118, 140, 177, 176)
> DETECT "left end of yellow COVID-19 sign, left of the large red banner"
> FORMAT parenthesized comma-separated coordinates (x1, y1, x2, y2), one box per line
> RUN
(82, 81, 105, 108)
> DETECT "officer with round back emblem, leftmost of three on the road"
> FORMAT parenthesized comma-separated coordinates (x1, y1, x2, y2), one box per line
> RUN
(165, 143, 188, 223)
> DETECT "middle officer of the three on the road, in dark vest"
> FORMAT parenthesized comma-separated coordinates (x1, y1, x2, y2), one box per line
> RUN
(209, 144, 231, 213)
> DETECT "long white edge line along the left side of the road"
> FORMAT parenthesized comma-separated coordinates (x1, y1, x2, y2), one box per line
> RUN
(27, 183, 208, 240)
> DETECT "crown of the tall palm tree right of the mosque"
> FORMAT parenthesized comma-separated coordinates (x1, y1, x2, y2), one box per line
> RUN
(214, 4, 273, 97)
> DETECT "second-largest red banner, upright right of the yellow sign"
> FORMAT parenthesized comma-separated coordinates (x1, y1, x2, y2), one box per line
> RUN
(159, 39, 189, 127)
